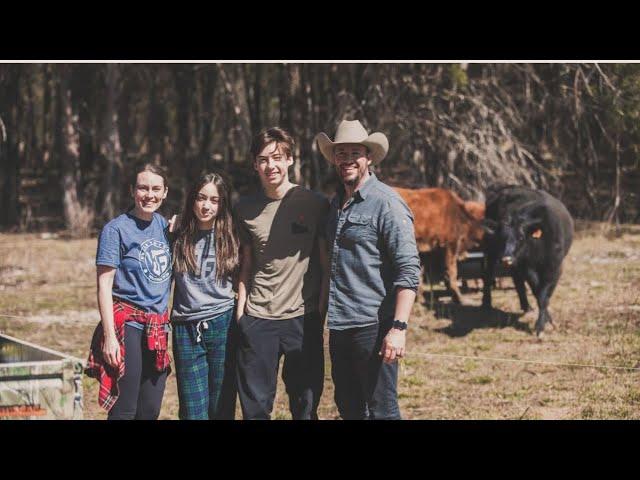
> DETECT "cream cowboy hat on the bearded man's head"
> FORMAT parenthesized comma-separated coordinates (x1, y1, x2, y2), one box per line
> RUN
(315, 120, 389, 165)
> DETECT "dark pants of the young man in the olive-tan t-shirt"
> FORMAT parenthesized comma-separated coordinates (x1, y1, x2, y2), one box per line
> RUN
(237, 313, 324, 420)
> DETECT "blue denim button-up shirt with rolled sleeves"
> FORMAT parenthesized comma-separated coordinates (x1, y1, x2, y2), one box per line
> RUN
(327, 173, 420, 330)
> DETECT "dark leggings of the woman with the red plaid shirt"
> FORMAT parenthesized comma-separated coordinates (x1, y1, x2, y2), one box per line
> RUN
(107, 325, 169, 420)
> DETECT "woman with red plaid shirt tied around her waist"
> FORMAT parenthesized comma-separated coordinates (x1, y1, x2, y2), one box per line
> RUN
(87, 163, 171, 420)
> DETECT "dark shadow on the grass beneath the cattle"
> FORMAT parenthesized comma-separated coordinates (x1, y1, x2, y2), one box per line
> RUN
(424, 292, 532, 338)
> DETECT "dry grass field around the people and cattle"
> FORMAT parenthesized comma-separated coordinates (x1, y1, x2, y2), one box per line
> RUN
(0, 224, 640, 419)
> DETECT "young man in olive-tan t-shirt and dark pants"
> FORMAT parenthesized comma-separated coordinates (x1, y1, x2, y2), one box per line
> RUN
(235, 127, 329, 420)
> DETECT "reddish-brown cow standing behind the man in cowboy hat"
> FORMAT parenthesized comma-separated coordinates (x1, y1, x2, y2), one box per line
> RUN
(394, 187, 484, 303)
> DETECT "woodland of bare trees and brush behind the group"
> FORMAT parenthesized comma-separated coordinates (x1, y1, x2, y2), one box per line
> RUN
(0, 63, 640, 237)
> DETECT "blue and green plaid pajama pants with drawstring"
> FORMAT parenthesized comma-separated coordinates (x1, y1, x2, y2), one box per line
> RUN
(173, 309, 235, 420)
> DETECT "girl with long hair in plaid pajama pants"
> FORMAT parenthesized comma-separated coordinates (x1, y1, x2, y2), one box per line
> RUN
(171, 173, 239, 420)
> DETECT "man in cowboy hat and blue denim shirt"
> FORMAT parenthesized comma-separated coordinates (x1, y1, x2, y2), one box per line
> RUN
(316, 120, 420, 419)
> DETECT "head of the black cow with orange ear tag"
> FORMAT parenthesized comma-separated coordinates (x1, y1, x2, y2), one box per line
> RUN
(483, 206, 544, 267)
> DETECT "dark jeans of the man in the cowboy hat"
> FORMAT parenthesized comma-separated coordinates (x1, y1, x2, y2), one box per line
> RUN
(329, 325, 401, 420)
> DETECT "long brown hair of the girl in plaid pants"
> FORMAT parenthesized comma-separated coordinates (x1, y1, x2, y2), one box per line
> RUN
(173, 173, 240, 283)
